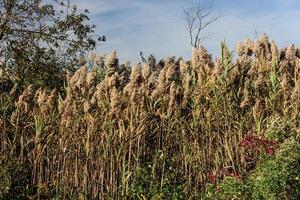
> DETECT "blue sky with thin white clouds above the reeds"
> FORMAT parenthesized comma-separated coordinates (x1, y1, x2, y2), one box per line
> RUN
(71, 0, 300, 63)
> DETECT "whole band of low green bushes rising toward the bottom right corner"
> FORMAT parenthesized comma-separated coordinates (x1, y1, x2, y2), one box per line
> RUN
(203, 138, 300, 200)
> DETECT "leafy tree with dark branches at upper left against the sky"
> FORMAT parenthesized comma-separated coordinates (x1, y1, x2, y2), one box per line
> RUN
(0, 0, 105, 88)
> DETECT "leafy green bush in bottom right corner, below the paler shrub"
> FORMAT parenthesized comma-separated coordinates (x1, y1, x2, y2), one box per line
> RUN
(249, 139, 300, 199)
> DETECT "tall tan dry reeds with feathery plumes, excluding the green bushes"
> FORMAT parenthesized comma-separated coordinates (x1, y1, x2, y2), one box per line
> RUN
(0, 35, 300, 199)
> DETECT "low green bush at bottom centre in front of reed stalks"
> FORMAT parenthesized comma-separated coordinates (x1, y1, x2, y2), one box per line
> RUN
(130, 151, 185, 200)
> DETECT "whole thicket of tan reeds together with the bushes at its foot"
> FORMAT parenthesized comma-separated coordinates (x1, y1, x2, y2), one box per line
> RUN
(0, 35, 300, 199)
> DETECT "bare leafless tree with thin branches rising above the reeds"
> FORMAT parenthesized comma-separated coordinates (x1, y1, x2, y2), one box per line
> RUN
(184, 5, 221, 48)
